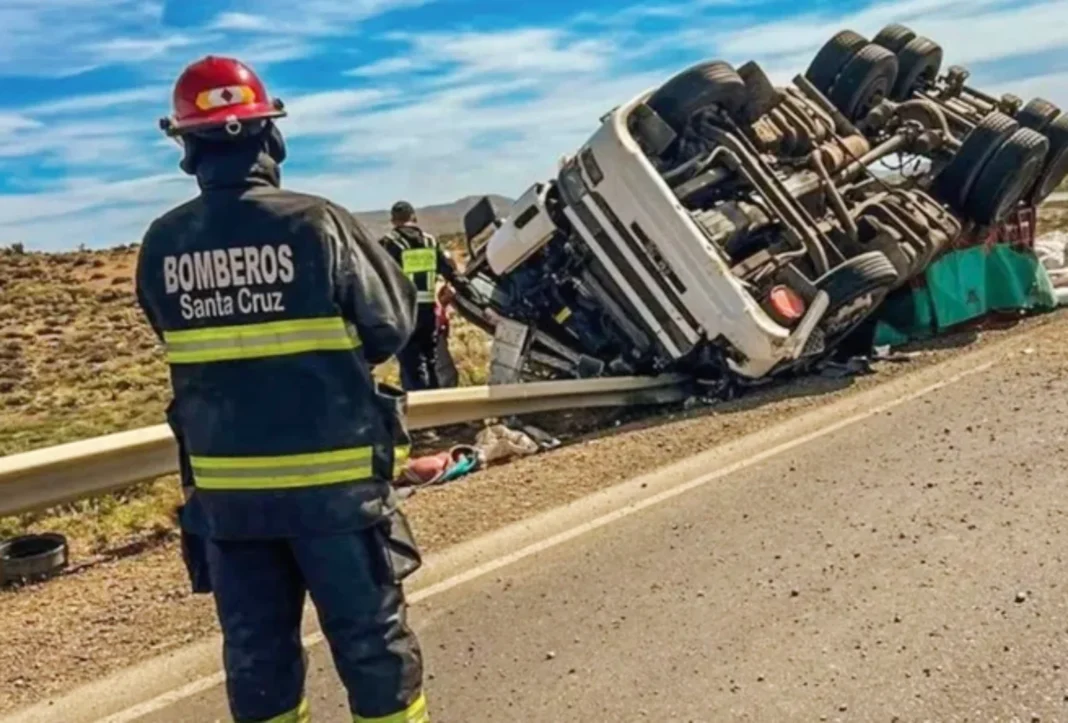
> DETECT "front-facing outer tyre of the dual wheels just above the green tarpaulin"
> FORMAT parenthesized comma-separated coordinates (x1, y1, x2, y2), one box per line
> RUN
(965, 128, 1050, 225)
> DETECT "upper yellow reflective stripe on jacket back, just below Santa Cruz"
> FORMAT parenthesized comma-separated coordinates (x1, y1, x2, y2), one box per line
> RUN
(163, 316, 360, 364)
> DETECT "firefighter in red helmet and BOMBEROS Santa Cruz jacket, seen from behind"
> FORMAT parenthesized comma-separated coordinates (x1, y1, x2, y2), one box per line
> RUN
(137, 57, 429, 723)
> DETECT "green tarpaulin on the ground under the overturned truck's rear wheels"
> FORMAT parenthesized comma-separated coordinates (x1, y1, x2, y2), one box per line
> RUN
(875, 243, 1057, 346)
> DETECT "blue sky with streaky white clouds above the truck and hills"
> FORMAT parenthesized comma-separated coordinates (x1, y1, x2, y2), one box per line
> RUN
(0, 0, 1068, 250)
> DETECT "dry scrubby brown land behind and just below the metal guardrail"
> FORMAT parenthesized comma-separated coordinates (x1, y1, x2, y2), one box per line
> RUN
(0, 239, 488, 556)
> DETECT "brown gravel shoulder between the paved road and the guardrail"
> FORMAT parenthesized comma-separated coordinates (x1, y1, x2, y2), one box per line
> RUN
(0, 314, 1068, 712)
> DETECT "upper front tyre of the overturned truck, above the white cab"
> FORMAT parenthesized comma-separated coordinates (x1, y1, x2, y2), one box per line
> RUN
(645, 61, 745, 133)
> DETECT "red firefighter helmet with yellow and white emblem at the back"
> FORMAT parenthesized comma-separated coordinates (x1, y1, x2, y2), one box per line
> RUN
(159, 56, 285, 136)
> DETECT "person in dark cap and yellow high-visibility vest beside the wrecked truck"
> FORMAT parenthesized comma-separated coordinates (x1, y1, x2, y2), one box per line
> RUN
(380, 201, 459, 392)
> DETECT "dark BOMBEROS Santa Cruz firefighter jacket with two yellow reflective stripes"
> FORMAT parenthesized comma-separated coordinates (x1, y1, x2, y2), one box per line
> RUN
(137, 142, 417, 539)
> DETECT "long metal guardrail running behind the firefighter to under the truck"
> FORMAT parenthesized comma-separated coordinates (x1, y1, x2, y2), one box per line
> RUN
(0, 376, 686, 516)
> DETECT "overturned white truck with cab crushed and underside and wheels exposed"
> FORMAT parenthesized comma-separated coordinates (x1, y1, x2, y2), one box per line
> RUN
(456, 25, 1068, 383)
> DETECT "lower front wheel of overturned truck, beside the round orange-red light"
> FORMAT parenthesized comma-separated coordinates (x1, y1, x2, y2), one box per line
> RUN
(816, 251, 898, 341)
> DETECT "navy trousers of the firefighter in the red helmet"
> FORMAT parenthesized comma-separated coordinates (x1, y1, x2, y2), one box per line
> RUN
(207, 531, 429, 723)
